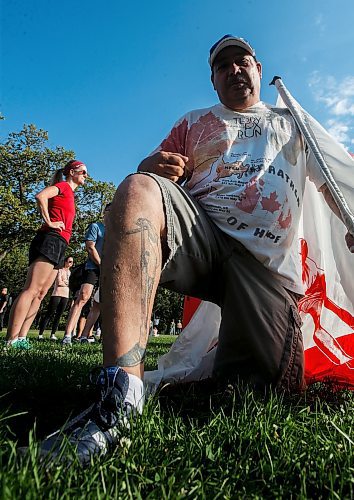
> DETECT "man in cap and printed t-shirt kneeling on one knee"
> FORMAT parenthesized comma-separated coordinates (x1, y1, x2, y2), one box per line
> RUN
(38, 35, 354, 462)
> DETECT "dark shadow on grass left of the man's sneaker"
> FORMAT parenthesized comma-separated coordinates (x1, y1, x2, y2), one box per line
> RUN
(0, 351, 94, 446)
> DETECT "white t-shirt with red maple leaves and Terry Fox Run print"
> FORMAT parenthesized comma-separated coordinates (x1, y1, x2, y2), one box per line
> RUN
(158, 102, 324, 293)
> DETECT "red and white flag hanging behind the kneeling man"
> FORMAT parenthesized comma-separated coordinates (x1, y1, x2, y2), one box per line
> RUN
(145, 98, 354, 391)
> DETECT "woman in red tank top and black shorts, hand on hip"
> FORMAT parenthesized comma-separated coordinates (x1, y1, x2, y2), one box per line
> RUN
(7, 160, 87, 349)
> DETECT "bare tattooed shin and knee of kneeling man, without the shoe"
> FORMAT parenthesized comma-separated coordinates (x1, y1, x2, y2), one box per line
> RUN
(100, 175, 165, 378)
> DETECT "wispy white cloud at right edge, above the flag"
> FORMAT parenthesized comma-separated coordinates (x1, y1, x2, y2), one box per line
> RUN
(308, 71, 354, 147)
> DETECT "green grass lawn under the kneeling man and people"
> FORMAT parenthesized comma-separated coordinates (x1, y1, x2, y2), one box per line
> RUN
(0, 330, 354, 499)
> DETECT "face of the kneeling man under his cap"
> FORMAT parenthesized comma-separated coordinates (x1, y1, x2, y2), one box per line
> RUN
(211, 47, 262, 111)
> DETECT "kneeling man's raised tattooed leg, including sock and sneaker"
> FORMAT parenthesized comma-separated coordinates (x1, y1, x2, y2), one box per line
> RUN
(36, 175, 166, 464)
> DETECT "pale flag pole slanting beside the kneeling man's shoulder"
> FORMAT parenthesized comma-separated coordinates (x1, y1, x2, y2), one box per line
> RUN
(269, 76, 354, 236)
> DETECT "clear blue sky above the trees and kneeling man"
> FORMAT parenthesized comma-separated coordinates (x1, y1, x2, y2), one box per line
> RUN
(0, 0, 354, 184)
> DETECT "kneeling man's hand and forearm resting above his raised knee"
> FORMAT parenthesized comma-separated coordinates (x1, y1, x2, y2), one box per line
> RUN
(138, 151, 188, 186)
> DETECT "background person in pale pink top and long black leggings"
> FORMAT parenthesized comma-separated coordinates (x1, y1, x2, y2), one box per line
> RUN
(38, 257, 74, 340)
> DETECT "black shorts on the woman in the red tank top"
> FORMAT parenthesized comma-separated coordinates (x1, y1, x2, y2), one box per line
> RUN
(28, 231, 68, 269)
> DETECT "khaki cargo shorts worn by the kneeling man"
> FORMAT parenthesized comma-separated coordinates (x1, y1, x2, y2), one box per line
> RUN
(134, 173, 305, 390)
